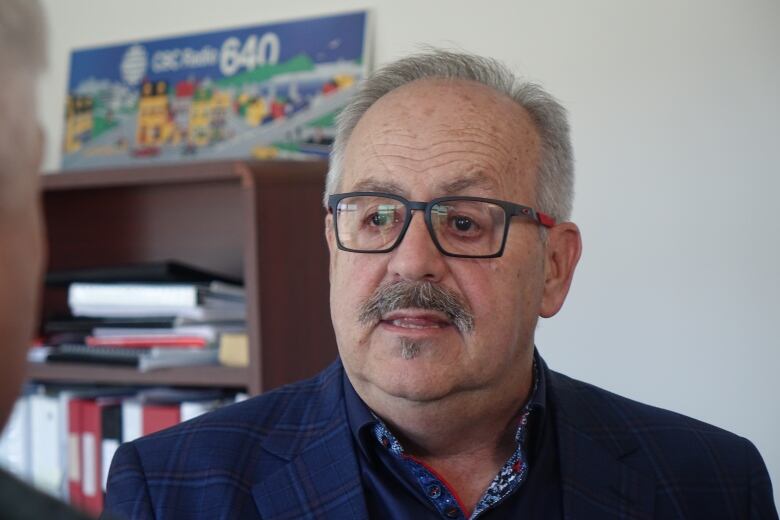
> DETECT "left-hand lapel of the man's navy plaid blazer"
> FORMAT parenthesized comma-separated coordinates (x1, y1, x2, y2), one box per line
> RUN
(252, 364, 368, 520)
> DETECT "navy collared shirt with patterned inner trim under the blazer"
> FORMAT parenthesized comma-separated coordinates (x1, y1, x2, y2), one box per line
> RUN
(344, 352, 562, 520)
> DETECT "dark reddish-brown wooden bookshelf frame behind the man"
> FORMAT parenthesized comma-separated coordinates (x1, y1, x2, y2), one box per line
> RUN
(28, 161, 336, 394)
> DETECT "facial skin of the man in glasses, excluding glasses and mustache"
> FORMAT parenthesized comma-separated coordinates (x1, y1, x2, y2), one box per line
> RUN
(326, 80, 545, 402)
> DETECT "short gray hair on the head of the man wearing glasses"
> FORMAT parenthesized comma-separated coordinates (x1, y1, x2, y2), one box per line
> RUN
(324, 49, 574, 222)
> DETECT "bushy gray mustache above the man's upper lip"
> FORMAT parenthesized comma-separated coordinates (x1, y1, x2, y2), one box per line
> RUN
(358, 280, 474, 333)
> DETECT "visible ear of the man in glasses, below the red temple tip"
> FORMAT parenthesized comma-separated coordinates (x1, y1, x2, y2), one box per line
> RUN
(539, 222, 582, 318)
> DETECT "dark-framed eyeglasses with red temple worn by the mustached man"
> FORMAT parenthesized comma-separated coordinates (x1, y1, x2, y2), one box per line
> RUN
(328, 191, 555, 258)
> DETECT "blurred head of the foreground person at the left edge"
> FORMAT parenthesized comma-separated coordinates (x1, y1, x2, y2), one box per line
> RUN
(0, 0, 46, 427)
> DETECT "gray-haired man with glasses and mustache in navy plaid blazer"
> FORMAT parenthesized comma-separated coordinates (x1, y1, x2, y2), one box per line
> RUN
(107, 51, 777, 519)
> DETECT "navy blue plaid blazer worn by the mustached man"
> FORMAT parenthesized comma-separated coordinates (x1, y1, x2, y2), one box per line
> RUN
(106, 361, 777, 520)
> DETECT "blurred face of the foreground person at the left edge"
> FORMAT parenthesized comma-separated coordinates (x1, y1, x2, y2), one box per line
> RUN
(0, 79, 44, 428)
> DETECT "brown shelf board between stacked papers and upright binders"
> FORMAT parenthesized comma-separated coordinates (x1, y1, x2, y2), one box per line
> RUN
(27, 363, 249, 388)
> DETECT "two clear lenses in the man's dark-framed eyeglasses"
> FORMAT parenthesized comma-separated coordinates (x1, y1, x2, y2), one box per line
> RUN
(336, 195, 506, 256)
